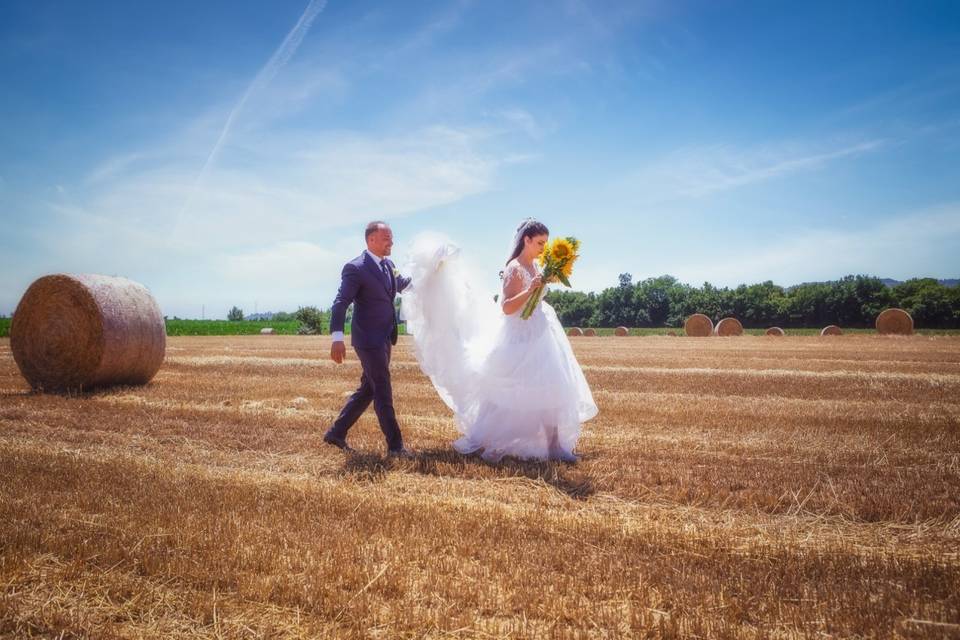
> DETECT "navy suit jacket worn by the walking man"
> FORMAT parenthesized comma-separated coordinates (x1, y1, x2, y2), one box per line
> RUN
(330, 251, 410, 349)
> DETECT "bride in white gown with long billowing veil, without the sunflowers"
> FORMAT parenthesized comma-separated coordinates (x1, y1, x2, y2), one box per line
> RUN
(403, 219, 597, 462)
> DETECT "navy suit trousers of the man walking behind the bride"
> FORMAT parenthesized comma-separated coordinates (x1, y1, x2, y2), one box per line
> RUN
(327, 340, 403, 451)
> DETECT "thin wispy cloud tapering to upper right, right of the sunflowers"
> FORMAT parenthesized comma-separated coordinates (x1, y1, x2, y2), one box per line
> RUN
(628, 138, 890, 202)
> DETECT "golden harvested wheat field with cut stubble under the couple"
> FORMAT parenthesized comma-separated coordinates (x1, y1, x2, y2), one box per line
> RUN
(0, 336, 960, 638)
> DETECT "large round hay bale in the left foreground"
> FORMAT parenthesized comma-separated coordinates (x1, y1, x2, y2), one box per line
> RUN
(10, 274, 167, 391)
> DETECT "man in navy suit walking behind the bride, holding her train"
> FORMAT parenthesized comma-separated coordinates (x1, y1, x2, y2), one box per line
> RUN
(323, 220, 413, 458)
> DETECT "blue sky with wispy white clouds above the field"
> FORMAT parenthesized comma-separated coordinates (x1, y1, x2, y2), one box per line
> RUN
(0, 0, 960, 317)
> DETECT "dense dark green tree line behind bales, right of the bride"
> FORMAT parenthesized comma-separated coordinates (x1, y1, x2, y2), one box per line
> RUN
(547, 273, 960, 329)
